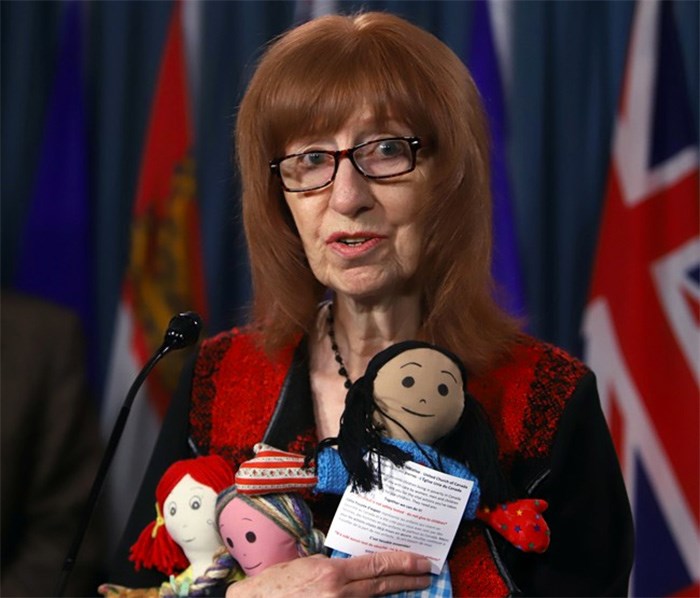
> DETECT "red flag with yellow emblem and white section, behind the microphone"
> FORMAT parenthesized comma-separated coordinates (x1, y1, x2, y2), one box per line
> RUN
(102, 2, 205, 548)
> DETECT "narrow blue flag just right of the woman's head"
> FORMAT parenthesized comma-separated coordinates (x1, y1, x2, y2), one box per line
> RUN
(468, 0, 527, 316)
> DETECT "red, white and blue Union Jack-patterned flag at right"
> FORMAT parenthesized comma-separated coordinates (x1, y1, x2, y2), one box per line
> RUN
(583, 0, 700, 596)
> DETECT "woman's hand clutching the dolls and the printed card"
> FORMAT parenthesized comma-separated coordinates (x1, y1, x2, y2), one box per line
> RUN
(226, 552, 430, 598)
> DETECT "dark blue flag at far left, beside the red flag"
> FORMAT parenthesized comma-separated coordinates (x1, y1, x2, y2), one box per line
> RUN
(13, 1, 92, 342)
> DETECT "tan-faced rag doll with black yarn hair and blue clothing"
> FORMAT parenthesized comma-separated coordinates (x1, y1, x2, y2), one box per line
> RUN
(316, 341, 549, 552)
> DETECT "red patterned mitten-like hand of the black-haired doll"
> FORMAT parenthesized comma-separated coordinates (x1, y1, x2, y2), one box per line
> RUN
(476, 498, 549, 552)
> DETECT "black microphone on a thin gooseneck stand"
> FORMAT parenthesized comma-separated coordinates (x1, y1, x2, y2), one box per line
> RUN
(56, 311, 202, 596)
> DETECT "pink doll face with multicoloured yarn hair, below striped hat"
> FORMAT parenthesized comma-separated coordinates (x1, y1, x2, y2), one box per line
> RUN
(216, 486, 325, 576)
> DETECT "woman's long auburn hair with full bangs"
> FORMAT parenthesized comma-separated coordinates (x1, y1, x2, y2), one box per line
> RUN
(235, 12, 517, 371)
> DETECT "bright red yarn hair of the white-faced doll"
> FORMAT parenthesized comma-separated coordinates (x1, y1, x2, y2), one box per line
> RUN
(129, 455, 234, 575)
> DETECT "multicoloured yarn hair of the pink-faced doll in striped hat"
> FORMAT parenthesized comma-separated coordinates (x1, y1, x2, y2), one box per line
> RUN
(216, 485, 326, 556)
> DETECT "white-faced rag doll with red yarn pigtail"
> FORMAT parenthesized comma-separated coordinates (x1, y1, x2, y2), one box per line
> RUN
(99, 455, 242, 598)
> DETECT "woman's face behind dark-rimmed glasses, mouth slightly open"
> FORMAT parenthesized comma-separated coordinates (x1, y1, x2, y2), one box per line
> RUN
(285, 111, 428, 301)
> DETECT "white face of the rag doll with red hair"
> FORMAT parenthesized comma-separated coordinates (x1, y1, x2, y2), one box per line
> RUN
(163, 474, 221, 554)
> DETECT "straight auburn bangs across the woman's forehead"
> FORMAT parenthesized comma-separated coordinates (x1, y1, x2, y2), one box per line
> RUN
(260, 24, 435, 157)
